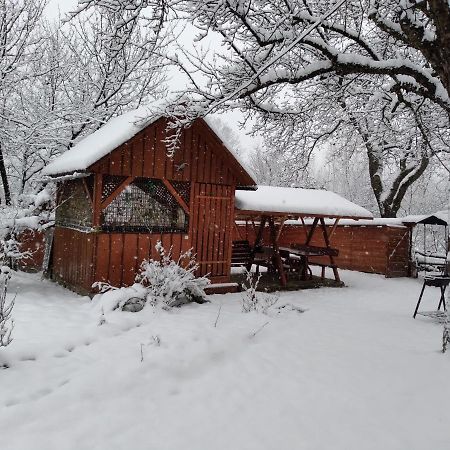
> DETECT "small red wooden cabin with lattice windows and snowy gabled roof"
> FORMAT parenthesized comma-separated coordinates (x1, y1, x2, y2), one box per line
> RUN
(44, 109, 255, 293)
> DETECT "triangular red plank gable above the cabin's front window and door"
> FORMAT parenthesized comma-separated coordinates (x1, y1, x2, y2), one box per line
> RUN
(88, 118, 254, 186)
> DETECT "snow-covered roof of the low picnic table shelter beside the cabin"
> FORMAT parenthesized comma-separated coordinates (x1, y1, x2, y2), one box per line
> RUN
(236, 186, 373, 219)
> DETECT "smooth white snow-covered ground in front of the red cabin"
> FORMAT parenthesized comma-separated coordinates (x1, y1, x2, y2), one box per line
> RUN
(0, 272, 450, 450)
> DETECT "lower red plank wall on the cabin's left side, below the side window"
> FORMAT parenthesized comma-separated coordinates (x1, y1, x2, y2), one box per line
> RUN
(52, 227, 97, 293)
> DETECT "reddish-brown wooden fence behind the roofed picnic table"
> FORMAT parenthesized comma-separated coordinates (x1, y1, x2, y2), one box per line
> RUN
(233, 223, 410, 277)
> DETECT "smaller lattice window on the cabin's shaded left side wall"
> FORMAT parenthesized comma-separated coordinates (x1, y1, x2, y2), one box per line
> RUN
(55, 177, 92, 230)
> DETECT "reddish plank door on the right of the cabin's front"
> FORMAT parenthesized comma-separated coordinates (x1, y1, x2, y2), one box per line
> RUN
(191, 183, 234, 283)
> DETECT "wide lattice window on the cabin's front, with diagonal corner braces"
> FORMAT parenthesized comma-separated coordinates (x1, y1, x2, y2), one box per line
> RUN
(102, 176, 190, 232)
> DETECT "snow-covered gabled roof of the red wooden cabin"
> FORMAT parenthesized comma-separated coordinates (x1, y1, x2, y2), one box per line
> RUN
(42, 103, 254, 178)
